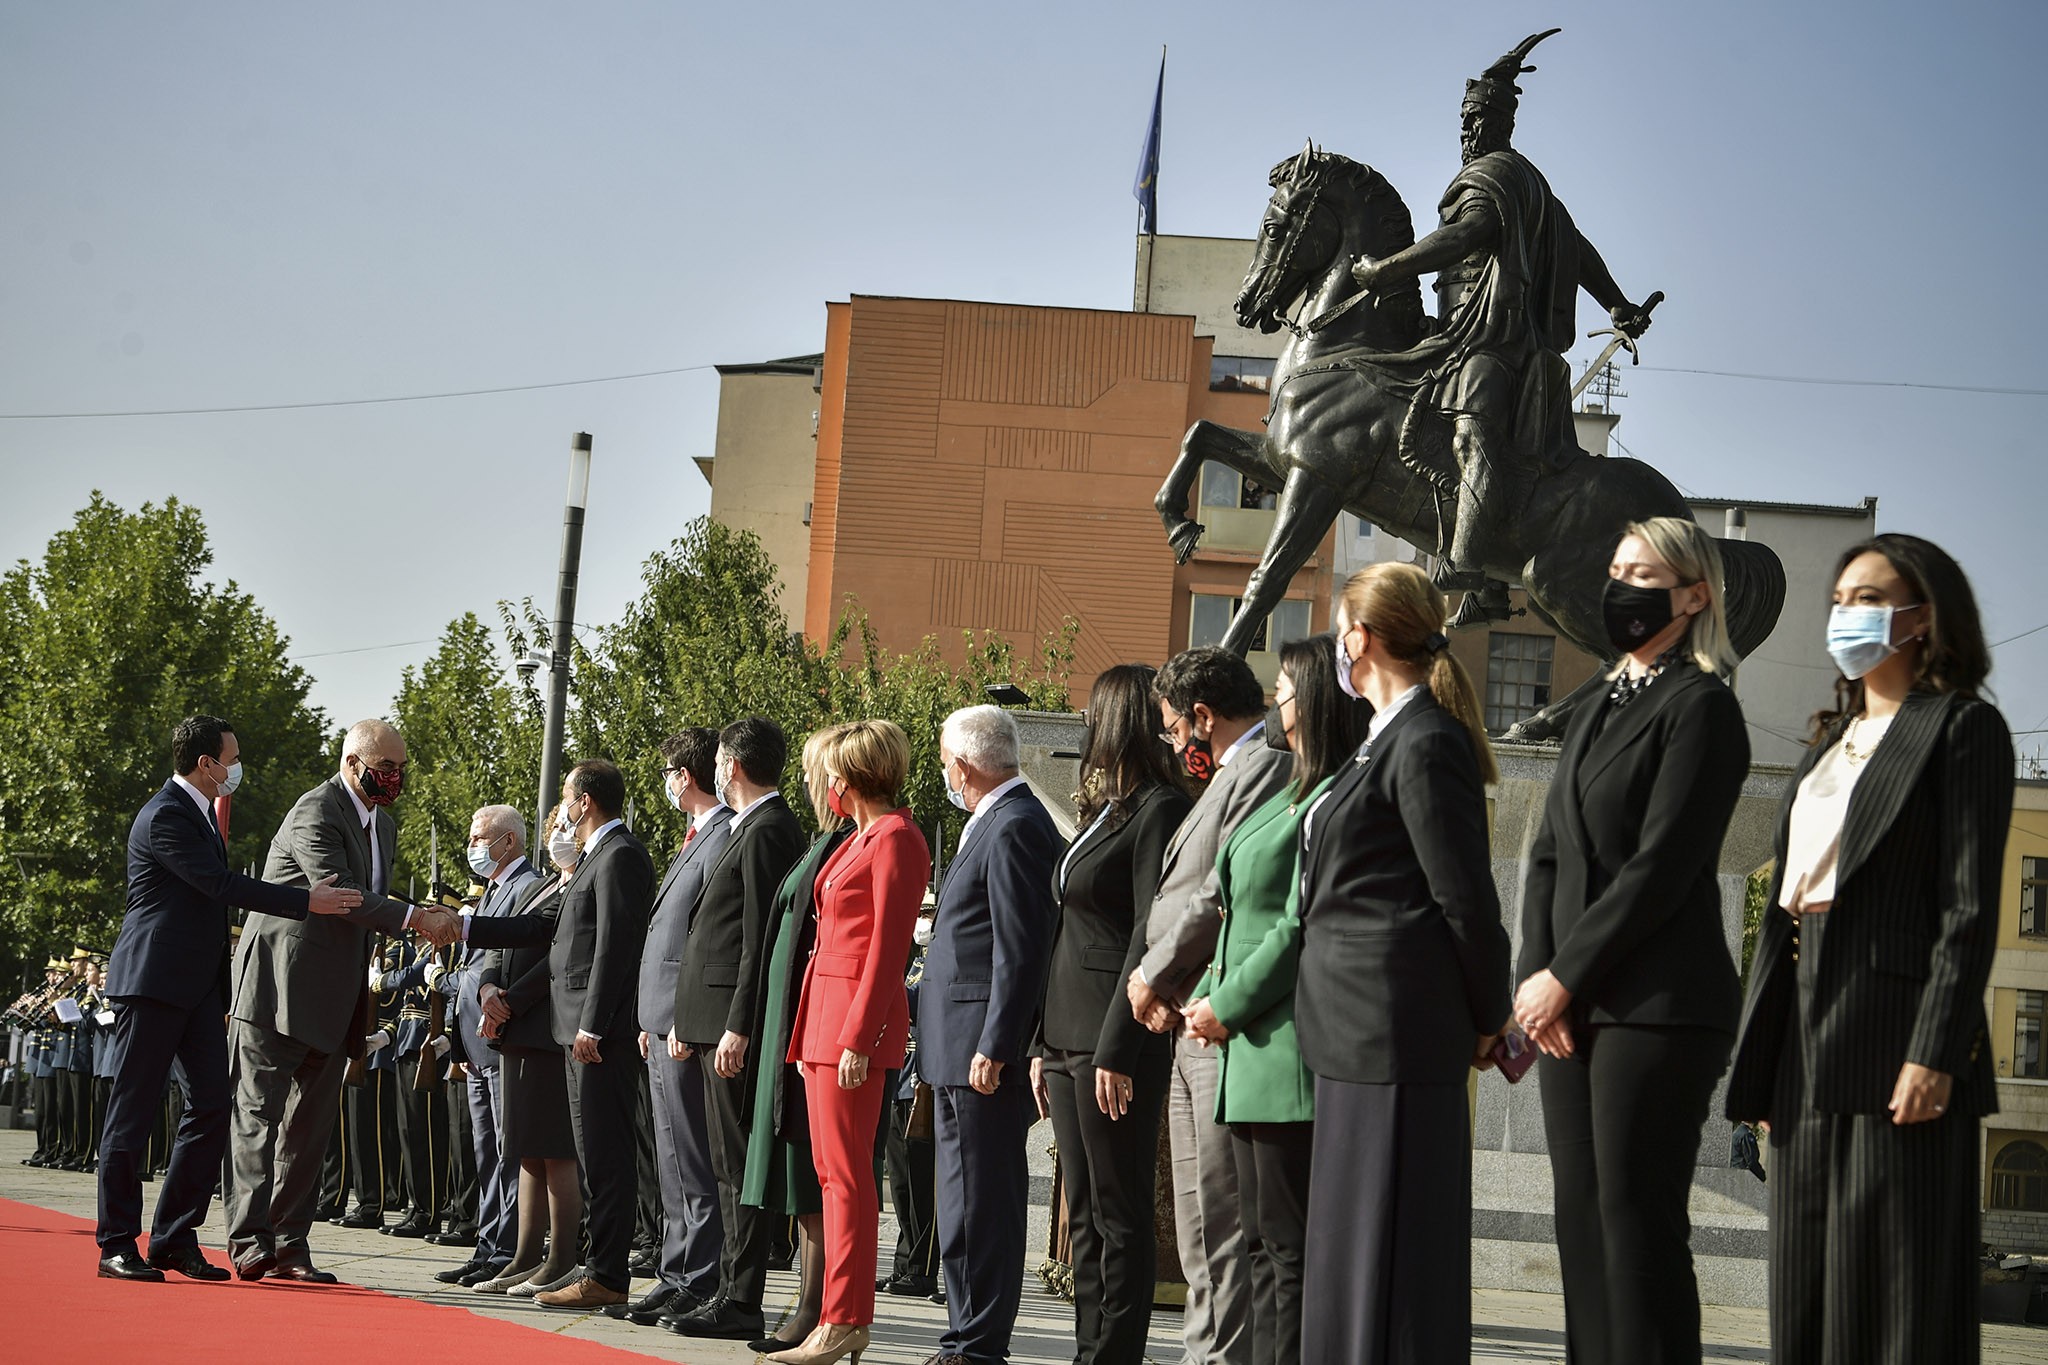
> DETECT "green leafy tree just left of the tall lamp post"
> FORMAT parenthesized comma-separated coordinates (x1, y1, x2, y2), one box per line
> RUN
(391, 612, 541, 900)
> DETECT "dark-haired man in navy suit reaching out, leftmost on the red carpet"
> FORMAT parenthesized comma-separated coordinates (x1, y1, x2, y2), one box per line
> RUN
(98, 716, 362, 1281)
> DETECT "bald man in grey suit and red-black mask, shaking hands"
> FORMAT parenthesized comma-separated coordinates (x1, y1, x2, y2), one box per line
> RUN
(227, 720, 455, 1285)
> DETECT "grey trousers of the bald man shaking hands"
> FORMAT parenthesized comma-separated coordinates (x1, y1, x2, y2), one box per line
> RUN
(227, 1019, 348, 1265)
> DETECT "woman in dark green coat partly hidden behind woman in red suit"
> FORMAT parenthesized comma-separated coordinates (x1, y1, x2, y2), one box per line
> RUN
(739, 724, 852, 1351)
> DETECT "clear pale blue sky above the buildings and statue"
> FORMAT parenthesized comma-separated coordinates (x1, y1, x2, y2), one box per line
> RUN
(0, 0, 2048, 745)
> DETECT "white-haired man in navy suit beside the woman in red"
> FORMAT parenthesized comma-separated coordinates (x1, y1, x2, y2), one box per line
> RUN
(918, 706, 1059, 1365)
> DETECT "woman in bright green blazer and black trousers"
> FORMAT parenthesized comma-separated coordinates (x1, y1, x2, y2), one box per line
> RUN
(1186, 634, 1372, 1365)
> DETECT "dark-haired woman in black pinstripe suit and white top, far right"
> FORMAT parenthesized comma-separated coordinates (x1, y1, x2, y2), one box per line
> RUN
(1729, 534, 2013, 1365)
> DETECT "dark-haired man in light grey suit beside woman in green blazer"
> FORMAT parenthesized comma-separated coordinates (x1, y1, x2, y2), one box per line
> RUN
(1126, 647, 1292, 1365)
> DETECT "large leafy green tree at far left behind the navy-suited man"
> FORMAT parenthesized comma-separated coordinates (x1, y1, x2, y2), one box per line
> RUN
(0, 491, 334, 978)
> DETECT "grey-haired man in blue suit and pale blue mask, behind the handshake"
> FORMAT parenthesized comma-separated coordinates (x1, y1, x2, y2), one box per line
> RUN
(412, 806, 541, 1285)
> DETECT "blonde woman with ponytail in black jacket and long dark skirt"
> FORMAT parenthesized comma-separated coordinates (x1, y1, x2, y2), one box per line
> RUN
(1294, 563, 1509, 1365)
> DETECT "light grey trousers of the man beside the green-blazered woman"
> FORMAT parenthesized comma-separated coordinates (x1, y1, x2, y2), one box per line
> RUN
(1165, 1040, 1251, 1365)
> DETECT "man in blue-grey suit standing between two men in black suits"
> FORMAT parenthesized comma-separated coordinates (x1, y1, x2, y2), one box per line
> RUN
(604, 726, 733, 1326)
